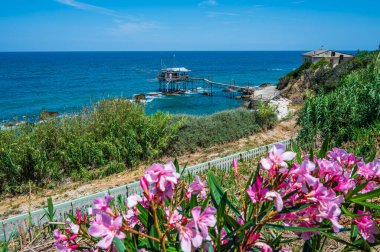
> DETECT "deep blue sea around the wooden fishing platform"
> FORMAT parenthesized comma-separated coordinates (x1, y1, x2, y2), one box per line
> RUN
(0, 51, 302, 123)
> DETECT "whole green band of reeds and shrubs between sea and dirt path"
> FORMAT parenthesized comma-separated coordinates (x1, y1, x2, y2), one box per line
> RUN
(0, 100, 276, 194)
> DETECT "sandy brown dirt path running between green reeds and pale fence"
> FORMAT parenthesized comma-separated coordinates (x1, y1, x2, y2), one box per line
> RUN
(0, 113, 297, 219)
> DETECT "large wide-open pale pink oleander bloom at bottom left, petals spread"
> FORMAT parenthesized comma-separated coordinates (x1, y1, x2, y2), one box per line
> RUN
(88, 213, 126, 249)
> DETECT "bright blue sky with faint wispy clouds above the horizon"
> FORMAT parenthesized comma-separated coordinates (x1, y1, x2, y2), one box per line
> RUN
(0, 0, 380, 51)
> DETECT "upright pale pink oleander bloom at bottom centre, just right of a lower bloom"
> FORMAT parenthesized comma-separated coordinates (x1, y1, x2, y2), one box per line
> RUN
(191, 206, 216, 243)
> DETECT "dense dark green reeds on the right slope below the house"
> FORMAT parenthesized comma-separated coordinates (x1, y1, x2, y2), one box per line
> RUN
(299, 52, 380, 152)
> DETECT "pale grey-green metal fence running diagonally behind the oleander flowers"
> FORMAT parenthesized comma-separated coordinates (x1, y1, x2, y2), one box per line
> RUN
(0, 138, 292, 241)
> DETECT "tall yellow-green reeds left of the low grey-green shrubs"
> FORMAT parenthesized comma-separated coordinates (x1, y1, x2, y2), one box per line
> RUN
(0, 100, 179, 194)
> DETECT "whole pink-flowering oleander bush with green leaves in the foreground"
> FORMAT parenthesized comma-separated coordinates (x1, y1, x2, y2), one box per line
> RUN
(53, 144, 380, 252)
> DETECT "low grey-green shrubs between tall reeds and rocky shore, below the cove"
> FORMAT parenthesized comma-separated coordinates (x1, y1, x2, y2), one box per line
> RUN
(174, 104, 276, 153)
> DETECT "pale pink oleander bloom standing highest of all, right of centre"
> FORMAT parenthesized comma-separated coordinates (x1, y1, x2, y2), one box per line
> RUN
(260, 144, 296, 170)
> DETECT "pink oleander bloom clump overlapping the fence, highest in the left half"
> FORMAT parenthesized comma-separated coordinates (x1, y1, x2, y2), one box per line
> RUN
(140, 162, 180, 200)
